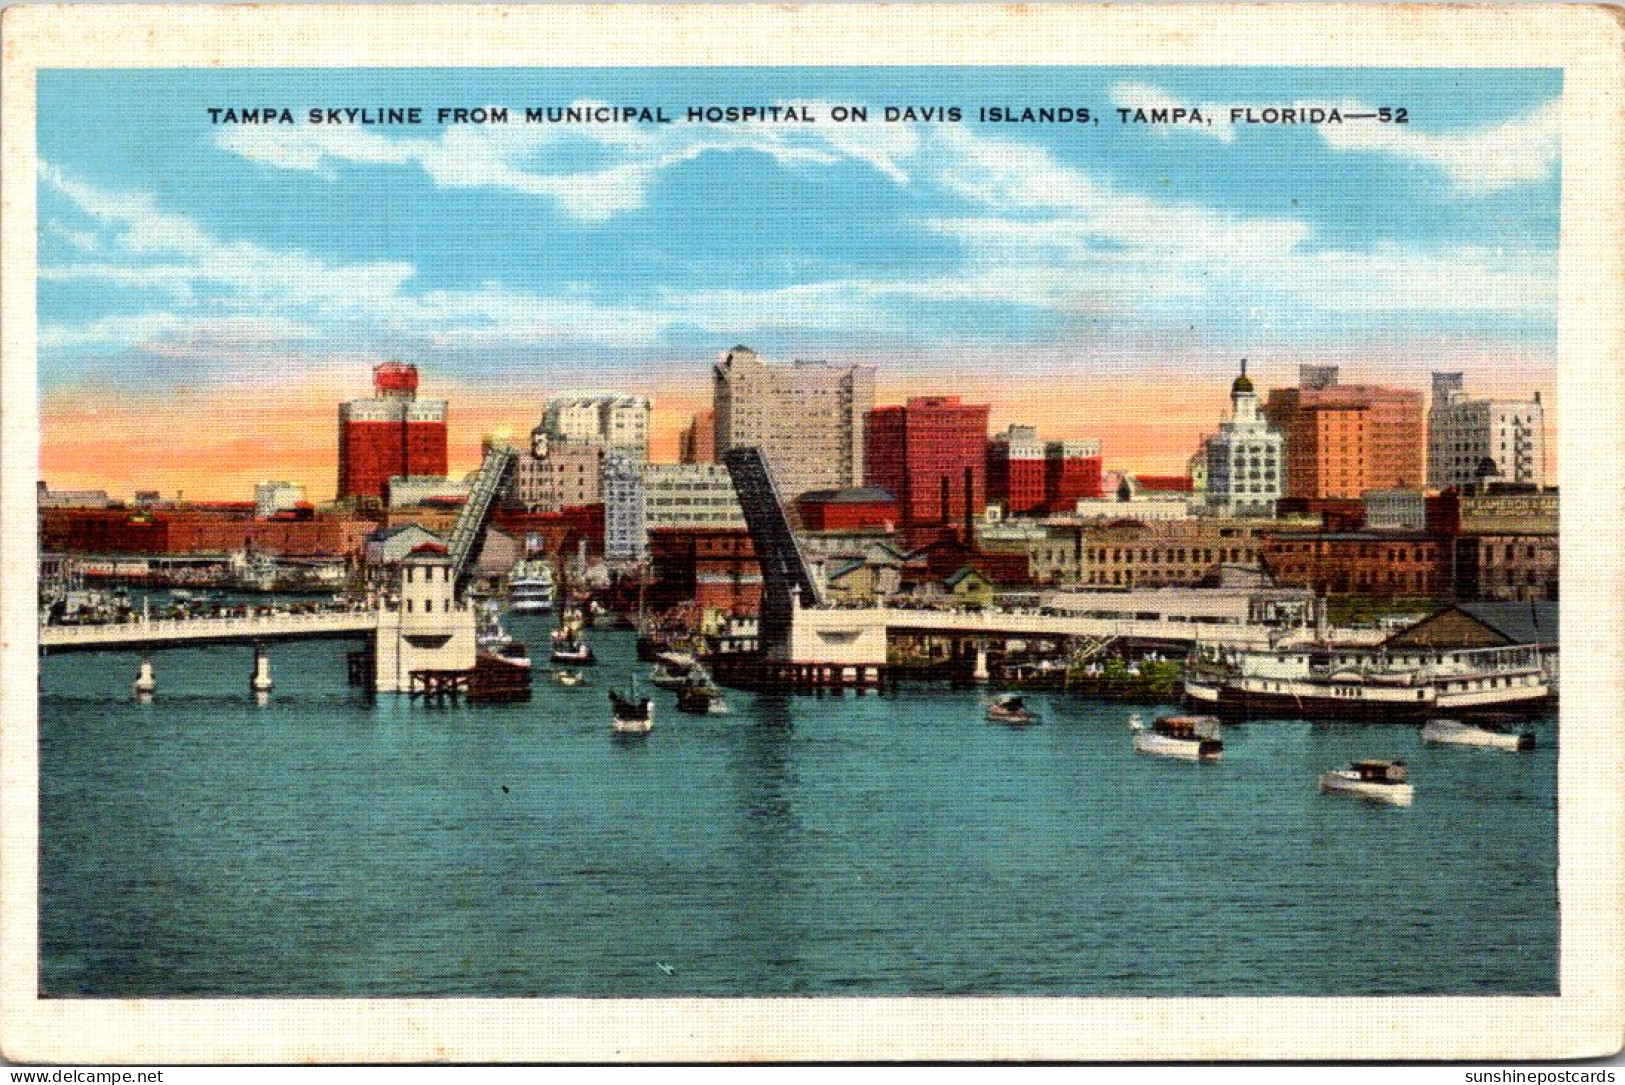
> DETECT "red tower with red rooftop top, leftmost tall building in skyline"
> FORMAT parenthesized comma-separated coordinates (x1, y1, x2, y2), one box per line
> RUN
(338, 362, 447, 500)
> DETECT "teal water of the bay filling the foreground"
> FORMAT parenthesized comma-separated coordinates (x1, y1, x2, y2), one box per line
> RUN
(39, 619, 1558, 997)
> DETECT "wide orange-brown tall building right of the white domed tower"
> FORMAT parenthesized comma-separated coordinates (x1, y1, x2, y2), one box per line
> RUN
(1254, 365, 1424, 497)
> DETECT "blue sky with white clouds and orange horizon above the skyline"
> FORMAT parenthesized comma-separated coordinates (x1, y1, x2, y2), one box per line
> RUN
(37, 68, 1562, 500)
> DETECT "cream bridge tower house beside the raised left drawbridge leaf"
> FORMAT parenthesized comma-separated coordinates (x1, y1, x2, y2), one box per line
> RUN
(372, 543, 476, 694)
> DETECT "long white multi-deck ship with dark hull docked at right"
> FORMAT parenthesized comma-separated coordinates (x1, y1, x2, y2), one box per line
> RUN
(1185, 645, 1552, 720)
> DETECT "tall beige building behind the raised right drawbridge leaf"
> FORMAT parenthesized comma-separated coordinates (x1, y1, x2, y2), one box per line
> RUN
(712, 346, 871, 502)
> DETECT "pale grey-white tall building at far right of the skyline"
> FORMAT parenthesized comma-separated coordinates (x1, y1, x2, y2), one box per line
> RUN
(1427, 374, 1545, 489)
